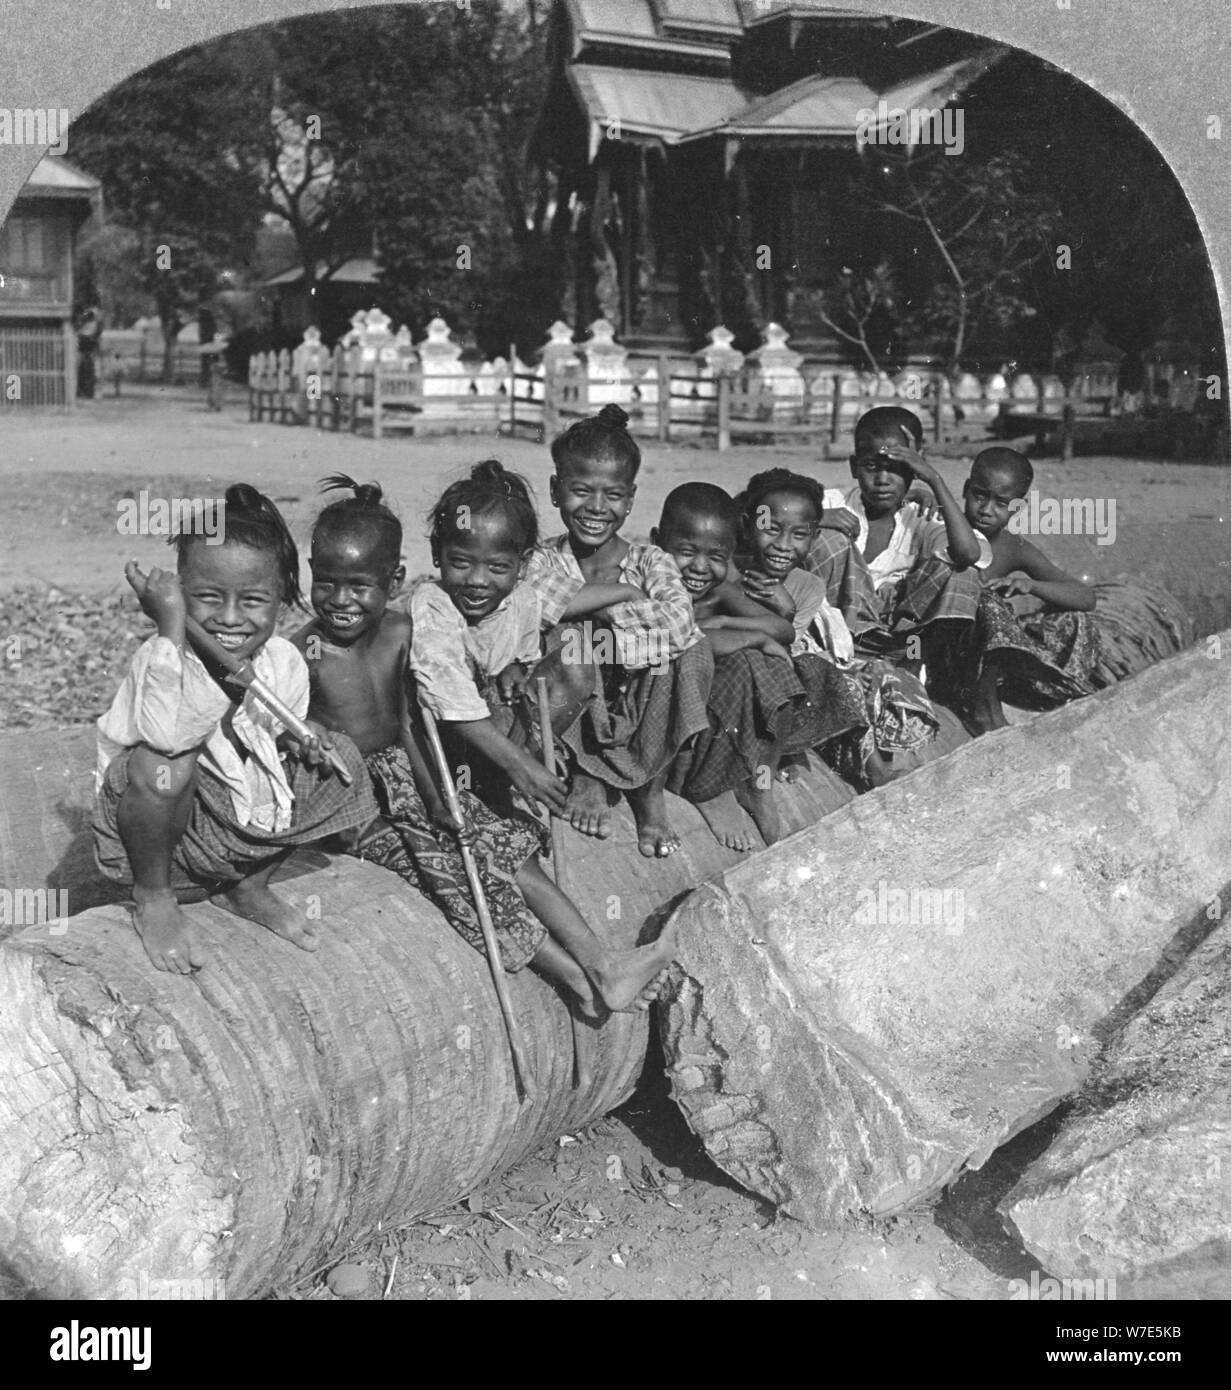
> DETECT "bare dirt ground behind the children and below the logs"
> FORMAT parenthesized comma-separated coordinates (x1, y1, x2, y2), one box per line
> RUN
(0, 388, 1231, 1301)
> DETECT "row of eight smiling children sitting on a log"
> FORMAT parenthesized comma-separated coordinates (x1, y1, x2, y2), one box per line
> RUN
(94, 406, 1128, 1019)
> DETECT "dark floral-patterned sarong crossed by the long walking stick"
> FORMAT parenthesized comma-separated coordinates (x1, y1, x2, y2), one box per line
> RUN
(353, 746, 549, 970)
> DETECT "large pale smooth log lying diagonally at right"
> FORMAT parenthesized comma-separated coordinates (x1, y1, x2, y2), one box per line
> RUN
(660, 635, 1231, 1225)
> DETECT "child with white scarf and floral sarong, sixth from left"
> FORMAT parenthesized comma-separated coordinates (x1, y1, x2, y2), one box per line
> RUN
(739, 468, 938, 788)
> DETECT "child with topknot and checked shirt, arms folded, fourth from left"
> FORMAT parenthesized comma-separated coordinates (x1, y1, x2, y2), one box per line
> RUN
(528, 404, 714, 858)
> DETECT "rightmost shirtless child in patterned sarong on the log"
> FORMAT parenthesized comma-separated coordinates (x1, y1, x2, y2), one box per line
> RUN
(955, 448, 1106, 734)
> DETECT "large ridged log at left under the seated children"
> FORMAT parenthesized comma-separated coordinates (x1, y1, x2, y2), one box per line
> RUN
(0, 728, 852, 1298)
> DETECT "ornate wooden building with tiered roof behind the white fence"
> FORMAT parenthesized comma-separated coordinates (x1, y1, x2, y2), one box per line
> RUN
(531, 0, 999, 356)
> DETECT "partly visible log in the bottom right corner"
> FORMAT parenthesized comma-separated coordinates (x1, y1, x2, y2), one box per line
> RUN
(1000, 917, 1231, 1300)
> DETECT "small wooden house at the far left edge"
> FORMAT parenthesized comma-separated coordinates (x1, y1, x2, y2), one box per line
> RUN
(0, 154, 101, 407)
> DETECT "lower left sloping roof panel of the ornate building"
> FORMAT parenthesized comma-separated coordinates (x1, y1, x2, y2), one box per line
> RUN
(568, 63, 747, 145)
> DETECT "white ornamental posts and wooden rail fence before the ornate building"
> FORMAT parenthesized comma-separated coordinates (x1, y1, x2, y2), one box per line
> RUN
(249, 310, 1205, 449)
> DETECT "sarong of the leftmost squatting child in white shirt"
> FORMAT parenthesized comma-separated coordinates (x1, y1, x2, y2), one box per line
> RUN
(93, 734, 377, 891)
